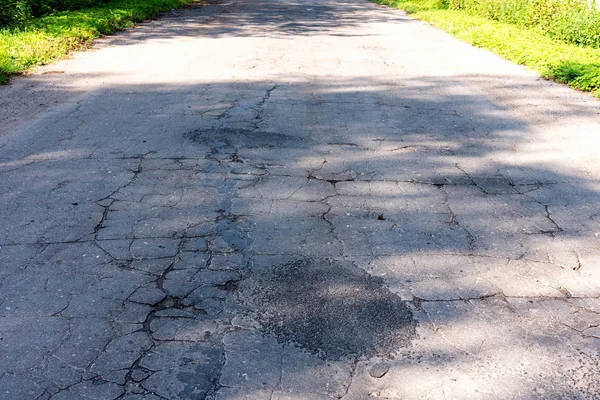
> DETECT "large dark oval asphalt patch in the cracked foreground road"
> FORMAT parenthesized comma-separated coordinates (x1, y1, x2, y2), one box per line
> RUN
(241, 259, 416, 360)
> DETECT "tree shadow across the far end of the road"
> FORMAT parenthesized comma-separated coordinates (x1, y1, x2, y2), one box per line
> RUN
(98, 0, 410, 45)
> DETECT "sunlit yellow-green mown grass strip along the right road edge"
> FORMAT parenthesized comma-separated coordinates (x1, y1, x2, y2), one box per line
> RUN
(373, 0, 600, 97)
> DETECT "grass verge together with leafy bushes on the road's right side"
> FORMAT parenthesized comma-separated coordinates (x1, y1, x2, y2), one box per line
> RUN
(374, 0, 600, 97)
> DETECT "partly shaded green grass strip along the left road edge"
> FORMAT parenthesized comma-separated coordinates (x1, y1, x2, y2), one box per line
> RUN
(0, 0, 194, 84)
